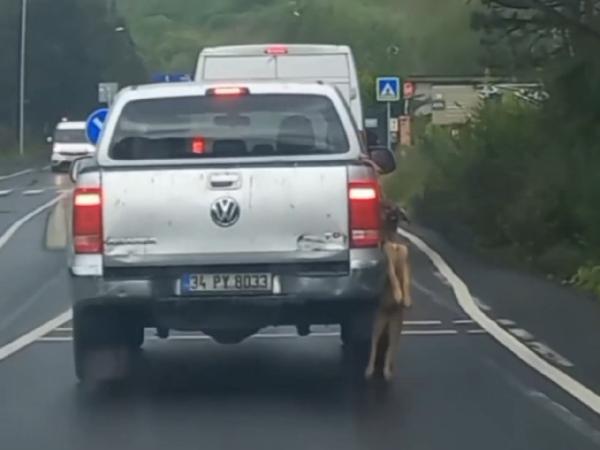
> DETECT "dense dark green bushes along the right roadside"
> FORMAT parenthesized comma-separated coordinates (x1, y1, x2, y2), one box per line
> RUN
(390, 89, 600, 295)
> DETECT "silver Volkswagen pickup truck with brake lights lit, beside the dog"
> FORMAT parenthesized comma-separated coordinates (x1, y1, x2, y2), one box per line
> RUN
(69, 83, 395, 379)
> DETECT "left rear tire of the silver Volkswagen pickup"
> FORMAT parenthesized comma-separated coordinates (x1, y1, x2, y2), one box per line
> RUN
(73, 307, 144, 383)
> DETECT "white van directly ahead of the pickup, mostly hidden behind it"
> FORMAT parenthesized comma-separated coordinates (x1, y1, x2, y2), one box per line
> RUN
(195, 44, 364, 131)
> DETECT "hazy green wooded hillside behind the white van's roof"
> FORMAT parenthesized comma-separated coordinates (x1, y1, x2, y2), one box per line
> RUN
(121, 0, 482, 100)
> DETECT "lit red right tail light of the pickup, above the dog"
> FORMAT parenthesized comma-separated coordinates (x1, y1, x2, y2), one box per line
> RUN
(348, 180, 381, 248)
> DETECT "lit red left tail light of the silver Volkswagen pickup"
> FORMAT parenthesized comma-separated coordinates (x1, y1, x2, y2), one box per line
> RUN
(73, 187, 103, 254)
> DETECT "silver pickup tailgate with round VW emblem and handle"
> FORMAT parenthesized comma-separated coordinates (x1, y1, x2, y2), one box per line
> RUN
(102, 165, 349, 267)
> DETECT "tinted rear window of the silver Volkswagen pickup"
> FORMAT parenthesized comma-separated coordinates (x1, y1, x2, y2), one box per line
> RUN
(109, 94, 349, 160)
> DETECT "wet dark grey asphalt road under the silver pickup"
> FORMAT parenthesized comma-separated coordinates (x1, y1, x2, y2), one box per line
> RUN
(0, 166, 600, 450)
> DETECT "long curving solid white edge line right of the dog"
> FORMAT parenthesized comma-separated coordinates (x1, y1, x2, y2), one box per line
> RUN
(398, 228, 600, 414)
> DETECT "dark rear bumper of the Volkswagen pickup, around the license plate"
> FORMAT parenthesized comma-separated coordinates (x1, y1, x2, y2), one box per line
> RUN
(71, 251, 386, 330)
